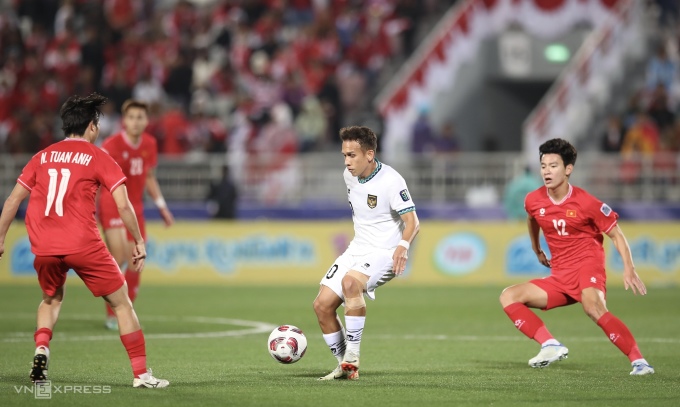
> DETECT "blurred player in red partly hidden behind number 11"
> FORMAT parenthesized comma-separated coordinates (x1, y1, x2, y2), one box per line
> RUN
(98, 100, 174, 330)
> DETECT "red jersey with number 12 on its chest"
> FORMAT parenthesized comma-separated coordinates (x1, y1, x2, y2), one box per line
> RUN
(524, 185, 619, 275)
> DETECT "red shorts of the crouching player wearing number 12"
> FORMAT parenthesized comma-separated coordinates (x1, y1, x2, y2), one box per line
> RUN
(529, 262, 607, 310)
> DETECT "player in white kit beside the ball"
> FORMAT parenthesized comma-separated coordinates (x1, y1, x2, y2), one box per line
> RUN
(314, 126, 419, 380)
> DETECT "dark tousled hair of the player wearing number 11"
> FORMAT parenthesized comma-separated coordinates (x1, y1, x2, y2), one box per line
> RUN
(59, 93, 108, 137)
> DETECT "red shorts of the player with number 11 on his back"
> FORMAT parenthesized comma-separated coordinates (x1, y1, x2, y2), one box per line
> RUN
(33, 242, 125, 297)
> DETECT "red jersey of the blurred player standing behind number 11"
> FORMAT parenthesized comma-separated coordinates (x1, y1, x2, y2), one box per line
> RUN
(99, 133, 158, 216)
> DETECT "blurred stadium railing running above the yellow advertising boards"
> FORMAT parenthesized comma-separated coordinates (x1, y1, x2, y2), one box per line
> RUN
(0, 152, 680, 206)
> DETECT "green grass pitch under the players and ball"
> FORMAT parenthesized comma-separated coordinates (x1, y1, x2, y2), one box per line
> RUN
(0, 283, 680, 407)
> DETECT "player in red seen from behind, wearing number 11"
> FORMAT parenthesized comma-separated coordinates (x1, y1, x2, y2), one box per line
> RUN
(0, 94, 169, 388)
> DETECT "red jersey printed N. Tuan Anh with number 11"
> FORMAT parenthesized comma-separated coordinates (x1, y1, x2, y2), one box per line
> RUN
(17, 139, 125, 256)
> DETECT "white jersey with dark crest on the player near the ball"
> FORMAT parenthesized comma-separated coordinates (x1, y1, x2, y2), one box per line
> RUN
(343, 160, 416, 254)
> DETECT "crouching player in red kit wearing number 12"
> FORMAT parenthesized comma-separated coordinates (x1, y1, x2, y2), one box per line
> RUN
(500, 139, 654, 375)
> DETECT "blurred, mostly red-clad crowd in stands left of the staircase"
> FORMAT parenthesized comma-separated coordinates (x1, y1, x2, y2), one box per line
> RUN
(0, 0, 453, 155)
